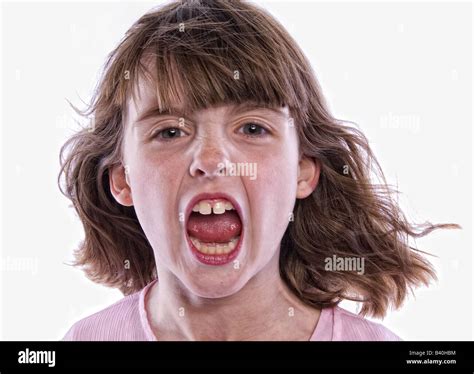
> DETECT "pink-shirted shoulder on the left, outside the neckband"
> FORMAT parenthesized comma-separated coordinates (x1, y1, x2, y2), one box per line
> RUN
(62, 292, 144, 341)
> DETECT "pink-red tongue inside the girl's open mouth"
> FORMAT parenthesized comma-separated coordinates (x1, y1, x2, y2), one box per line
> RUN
(187, 210, 242, 243)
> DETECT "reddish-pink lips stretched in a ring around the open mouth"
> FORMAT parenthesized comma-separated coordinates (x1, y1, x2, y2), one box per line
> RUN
(184, 193, 245, 266)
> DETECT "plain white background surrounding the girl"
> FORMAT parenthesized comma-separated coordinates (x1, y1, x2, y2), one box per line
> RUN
(0, 2, 473, 340)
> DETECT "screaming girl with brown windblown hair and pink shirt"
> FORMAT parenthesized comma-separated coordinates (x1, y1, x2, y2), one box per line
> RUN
(61, 0, 455, 340)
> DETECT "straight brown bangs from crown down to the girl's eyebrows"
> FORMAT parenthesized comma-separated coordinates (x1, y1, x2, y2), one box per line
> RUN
(110, 1, 308, 113)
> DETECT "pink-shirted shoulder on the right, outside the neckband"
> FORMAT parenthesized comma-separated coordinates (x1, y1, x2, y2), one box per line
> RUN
(333, 306, 401, 341)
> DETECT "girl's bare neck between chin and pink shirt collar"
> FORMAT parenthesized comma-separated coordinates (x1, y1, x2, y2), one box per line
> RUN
(147, 251, 319, 341)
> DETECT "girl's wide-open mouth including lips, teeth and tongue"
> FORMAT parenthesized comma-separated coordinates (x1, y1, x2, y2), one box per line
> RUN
(186, 195, 243, 265)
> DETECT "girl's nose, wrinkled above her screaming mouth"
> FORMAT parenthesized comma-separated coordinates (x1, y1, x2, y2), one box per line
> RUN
(189, 139, 229, 178)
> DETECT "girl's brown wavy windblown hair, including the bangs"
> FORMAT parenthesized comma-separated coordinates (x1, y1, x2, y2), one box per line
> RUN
(58, 0, 459, 317)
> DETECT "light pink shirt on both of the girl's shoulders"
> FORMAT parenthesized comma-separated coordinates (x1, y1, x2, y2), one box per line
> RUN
(63, 281, 401, 341)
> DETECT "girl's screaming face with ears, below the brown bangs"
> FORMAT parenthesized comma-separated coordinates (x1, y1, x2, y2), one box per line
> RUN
(111, 76, 319, 298)
